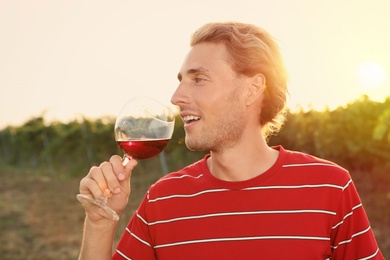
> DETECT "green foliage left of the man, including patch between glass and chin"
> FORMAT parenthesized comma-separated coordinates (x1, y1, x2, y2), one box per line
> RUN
(0, 116, 205, 176)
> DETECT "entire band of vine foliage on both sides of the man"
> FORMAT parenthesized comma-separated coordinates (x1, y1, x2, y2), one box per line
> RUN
(0, 96, 390, 176)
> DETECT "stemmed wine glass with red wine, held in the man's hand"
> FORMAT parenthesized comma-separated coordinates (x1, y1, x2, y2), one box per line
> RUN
(77, 97, 175, 221)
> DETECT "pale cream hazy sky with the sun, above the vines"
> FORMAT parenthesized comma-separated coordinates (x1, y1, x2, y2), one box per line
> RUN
(0, 0, 390, 129)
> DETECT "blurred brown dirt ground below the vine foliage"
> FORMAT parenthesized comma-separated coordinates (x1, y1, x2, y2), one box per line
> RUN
(0, 170, 390, 260)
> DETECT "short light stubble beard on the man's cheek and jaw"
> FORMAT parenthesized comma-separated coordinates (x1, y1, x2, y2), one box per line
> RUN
(185, 88, 244, 152)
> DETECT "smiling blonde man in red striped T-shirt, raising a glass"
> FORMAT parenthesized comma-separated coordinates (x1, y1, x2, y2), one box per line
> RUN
(80, 23, 383, 259)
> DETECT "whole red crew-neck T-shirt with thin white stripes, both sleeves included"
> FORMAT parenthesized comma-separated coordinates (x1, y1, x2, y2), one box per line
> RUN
(113, 147, 384, 260)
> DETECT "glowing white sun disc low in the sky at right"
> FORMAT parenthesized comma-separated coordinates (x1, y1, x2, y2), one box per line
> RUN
(356, 61, 387, 89)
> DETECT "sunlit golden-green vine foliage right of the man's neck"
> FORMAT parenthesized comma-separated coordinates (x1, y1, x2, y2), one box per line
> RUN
(270, 96, 390, 171)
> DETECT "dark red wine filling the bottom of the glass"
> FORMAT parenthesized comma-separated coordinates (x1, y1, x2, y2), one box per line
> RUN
(117, 139, 169, 160)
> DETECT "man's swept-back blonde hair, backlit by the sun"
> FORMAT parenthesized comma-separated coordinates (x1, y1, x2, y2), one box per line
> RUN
(190, 22, 288, 139)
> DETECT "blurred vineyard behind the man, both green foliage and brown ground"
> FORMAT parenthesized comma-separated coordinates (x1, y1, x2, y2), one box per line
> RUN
(0, 96, 390, 259)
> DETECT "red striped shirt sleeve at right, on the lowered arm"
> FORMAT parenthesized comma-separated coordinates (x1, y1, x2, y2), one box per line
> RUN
(331, 179, 384, 260)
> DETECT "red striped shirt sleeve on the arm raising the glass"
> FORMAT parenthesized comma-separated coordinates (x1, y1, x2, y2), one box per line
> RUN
(112, 193, 157, 260)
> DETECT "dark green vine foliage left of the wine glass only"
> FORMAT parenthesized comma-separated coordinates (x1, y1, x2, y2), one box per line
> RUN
(0, 117, 118, 175)
